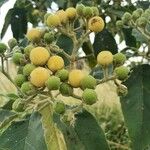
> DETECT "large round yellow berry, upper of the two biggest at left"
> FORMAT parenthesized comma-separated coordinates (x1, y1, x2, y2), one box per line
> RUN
(30, 47, 50, 65)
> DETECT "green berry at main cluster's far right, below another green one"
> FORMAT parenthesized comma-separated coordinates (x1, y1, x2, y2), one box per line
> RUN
(114, 66, 129, 80)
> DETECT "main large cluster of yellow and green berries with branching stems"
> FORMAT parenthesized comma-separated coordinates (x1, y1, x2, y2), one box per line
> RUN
(0, 4, 129, 117)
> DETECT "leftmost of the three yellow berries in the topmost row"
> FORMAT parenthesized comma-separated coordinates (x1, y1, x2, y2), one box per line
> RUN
(47, 15, 61, 27)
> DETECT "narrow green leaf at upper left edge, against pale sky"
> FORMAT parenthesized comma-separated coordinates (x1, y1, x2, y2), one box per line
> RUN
(1, 8, 14, 38)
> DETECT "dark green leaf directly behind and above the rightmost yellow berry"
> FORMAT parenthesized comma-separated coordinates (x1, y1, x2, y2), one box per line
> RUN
(93, 29, 118, 56)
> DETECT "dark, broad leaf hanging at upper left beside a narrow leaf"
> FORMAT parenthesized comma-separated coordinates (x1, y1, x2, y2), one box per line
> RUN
(10, 7, 27, 40)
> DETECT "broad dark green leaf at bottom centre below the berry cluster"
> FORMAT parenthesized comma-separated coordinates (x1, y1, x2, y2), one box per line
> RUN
(54, 111, 109, 150)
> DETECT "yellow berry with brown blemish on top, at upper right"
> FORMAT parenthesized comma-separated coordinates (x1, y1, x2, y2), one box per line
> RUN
(88, 16, 105, 32)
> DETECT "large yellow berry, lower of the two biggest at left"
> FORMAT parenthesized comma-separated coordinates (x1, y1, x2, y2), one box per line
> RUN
(30, 67, 50, 87)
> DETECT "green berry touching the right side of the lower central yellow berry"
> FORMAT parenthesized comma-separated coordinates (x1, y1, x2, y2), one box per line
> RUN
(81, 75, 96, 89)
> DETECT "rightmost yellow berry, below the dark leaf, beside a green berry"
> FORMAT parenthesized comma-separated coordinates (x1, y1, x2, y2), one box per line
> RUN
(97, 51, 113, 66)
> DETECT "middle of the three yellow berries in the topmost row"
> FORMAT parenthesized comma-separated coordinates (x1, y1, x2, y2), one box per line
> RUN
(56, 10, 68, 24)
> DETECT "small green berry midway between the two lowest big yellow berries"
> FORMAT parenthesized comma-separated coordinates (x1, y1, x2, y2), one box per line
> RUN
(56, 69, 69, 81)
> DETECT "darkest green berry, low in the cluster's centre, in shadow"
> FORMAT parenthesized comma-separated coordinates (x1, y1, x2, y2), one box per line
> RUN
(59, 83, 73, 96)
